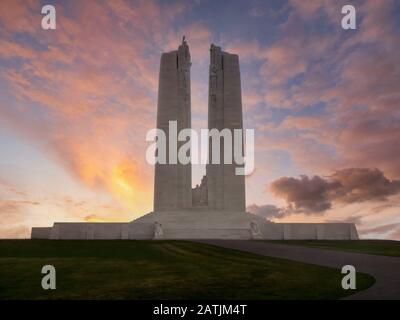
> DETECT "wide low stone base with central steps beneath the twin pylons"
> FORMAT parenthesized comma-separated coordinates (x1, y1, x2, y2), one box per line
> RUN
(31, 207, 358, 240)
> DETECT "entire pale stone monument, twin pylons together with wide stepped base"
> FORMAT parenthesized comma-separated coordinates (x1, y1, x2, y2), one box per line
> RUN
(31, 38, 358, 240)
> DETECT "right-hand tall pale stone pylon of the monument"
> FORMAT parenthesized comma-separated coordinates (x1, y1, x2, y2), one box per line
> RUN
(207, 44, 246, 211)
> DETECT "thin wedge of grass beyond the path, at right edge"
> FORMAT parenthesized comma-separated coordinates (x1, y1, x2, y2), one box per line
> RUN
(268, 240, 400, 257)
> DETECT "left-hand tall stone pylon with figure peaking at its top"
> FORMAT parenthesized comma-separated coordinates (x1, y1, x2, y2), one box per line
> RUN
(154, 37, 192, 211)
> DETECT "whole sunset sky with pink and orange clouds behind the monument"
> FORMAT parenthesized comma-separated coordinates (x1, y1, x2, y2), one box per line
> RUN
(0, 0, 400, 240)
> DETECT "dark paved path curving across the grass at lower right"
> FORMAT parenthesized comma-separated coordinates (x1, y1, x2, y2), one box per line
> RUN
(198, 240, 400, 300)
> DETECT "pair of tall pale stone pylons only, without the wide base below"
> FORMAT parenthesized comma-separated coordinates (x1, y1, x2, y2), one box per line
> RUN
(154, 40, 246, 212)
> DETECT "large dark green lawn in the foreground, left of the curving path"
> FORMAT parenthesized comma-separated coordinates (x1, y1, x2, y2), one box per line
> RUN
(0, 240, 374, 299)
